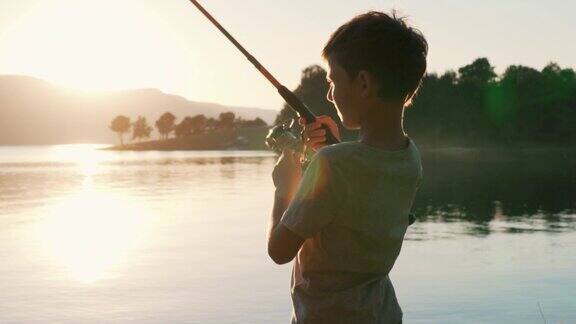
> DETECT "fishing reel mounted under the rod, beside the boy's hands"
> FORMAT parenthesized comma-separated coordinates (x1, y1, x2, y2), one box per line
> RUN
(266, 118, 306, 154)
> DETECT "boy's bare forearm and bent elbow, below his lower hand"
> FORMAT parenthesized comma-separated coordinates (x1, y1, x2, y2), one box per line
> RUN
(268, 190, 305, 264)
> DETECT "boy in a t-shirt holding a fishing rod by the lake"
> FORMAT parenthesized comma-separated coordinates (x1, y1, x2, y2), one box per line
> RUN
(268, 12, 427, 324)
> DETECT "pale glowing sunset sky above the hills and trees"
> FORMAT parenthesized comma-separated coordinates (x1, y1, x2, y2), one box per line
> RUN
(0, 0, 576, 110)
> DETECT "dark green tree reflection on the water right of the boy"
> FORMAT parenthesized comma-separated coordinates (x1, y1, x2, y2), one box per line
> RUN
(414, 151, 576, 235)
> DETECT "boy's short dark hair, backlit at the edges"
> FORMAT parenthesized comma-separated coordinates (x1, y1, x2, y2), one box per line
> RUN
(322, 11, 428, 100)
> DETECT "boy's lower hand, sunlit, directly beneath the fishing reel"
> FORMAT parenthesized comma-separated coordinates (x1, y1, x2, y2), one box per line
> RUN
(272, 149, 302, 200)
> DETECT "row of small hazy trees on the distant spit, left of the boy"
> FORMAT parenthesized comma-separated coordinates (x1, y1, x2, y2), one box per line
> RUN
(109, 112, 268, 145)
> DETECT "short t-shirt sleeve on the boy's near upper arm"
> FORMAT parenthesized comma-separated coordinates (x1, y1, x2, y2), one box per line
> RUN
(280, 153, 334, 238)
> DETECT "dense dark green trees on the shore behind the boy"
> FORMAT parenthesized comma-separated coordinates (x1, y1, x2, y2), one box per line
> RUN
(276, 58, 576, 145)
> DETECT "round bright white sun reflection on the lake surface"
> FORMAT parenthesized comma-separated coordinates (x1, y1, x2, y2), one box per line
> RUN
(35, 173, 147, 283)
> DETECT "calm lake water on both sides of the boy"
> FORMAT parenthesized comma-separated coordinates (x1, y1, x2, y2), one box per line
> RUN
(0, 145, 576, 323)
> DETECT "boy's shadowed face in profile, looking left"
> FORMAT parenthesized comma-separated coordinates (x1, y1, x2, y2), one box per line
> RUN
(326, 57, 361, 129)
